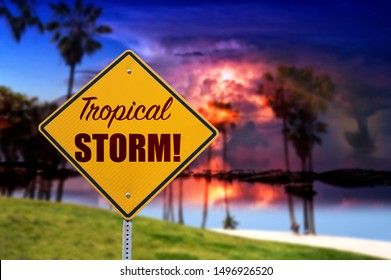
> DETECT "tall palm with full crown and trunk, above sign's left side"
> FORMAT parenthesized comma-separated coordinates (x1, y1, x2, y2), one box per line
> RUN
(46, 0, 112, 98)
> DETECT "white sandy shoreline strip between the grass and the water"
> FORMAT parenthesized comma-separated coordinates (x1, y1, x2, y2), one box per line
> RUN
(209, 229, 391, 259)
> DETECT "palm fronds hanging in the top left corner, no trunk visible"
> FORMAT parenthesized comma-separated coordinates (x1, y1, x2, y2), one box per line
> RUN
(0, 0, 43, 42)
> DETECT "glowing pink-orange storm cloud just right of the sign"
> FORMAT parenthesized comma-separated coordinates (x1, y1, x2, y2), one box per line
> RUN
(171, 61, 274, 124)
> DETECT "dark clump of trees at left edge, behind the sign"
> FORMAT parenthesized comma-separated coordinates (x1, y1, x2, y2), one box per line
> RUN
(0, 87, 62, 199)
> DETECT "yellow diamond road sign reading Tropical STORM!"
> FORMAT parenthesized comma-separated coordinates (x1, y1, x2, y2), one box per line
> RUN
(39, 51, 217, 220)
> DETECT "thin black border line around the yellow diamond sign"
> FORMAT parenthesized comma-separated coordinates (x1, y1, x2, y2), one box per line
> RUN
(40, 51, 217, 218)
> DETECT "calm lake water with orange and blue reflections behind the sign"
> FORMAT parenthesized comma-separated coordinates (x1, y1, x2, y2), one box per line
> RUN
(60, 177, 391, 241)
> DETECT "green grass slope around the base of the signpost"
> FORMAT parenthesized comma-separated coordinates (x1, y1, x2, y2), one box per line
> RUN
(0, 197, 380, 260)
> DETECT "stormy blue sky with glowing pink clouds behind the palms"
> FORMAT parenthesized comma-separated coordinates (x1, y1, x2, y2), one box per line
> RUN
(0, 0, 391, 170)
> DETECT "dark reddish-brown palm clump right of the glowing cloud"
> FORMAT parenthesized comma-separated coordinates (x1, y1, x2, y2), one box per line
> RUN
(257, 66, 335, 171)
